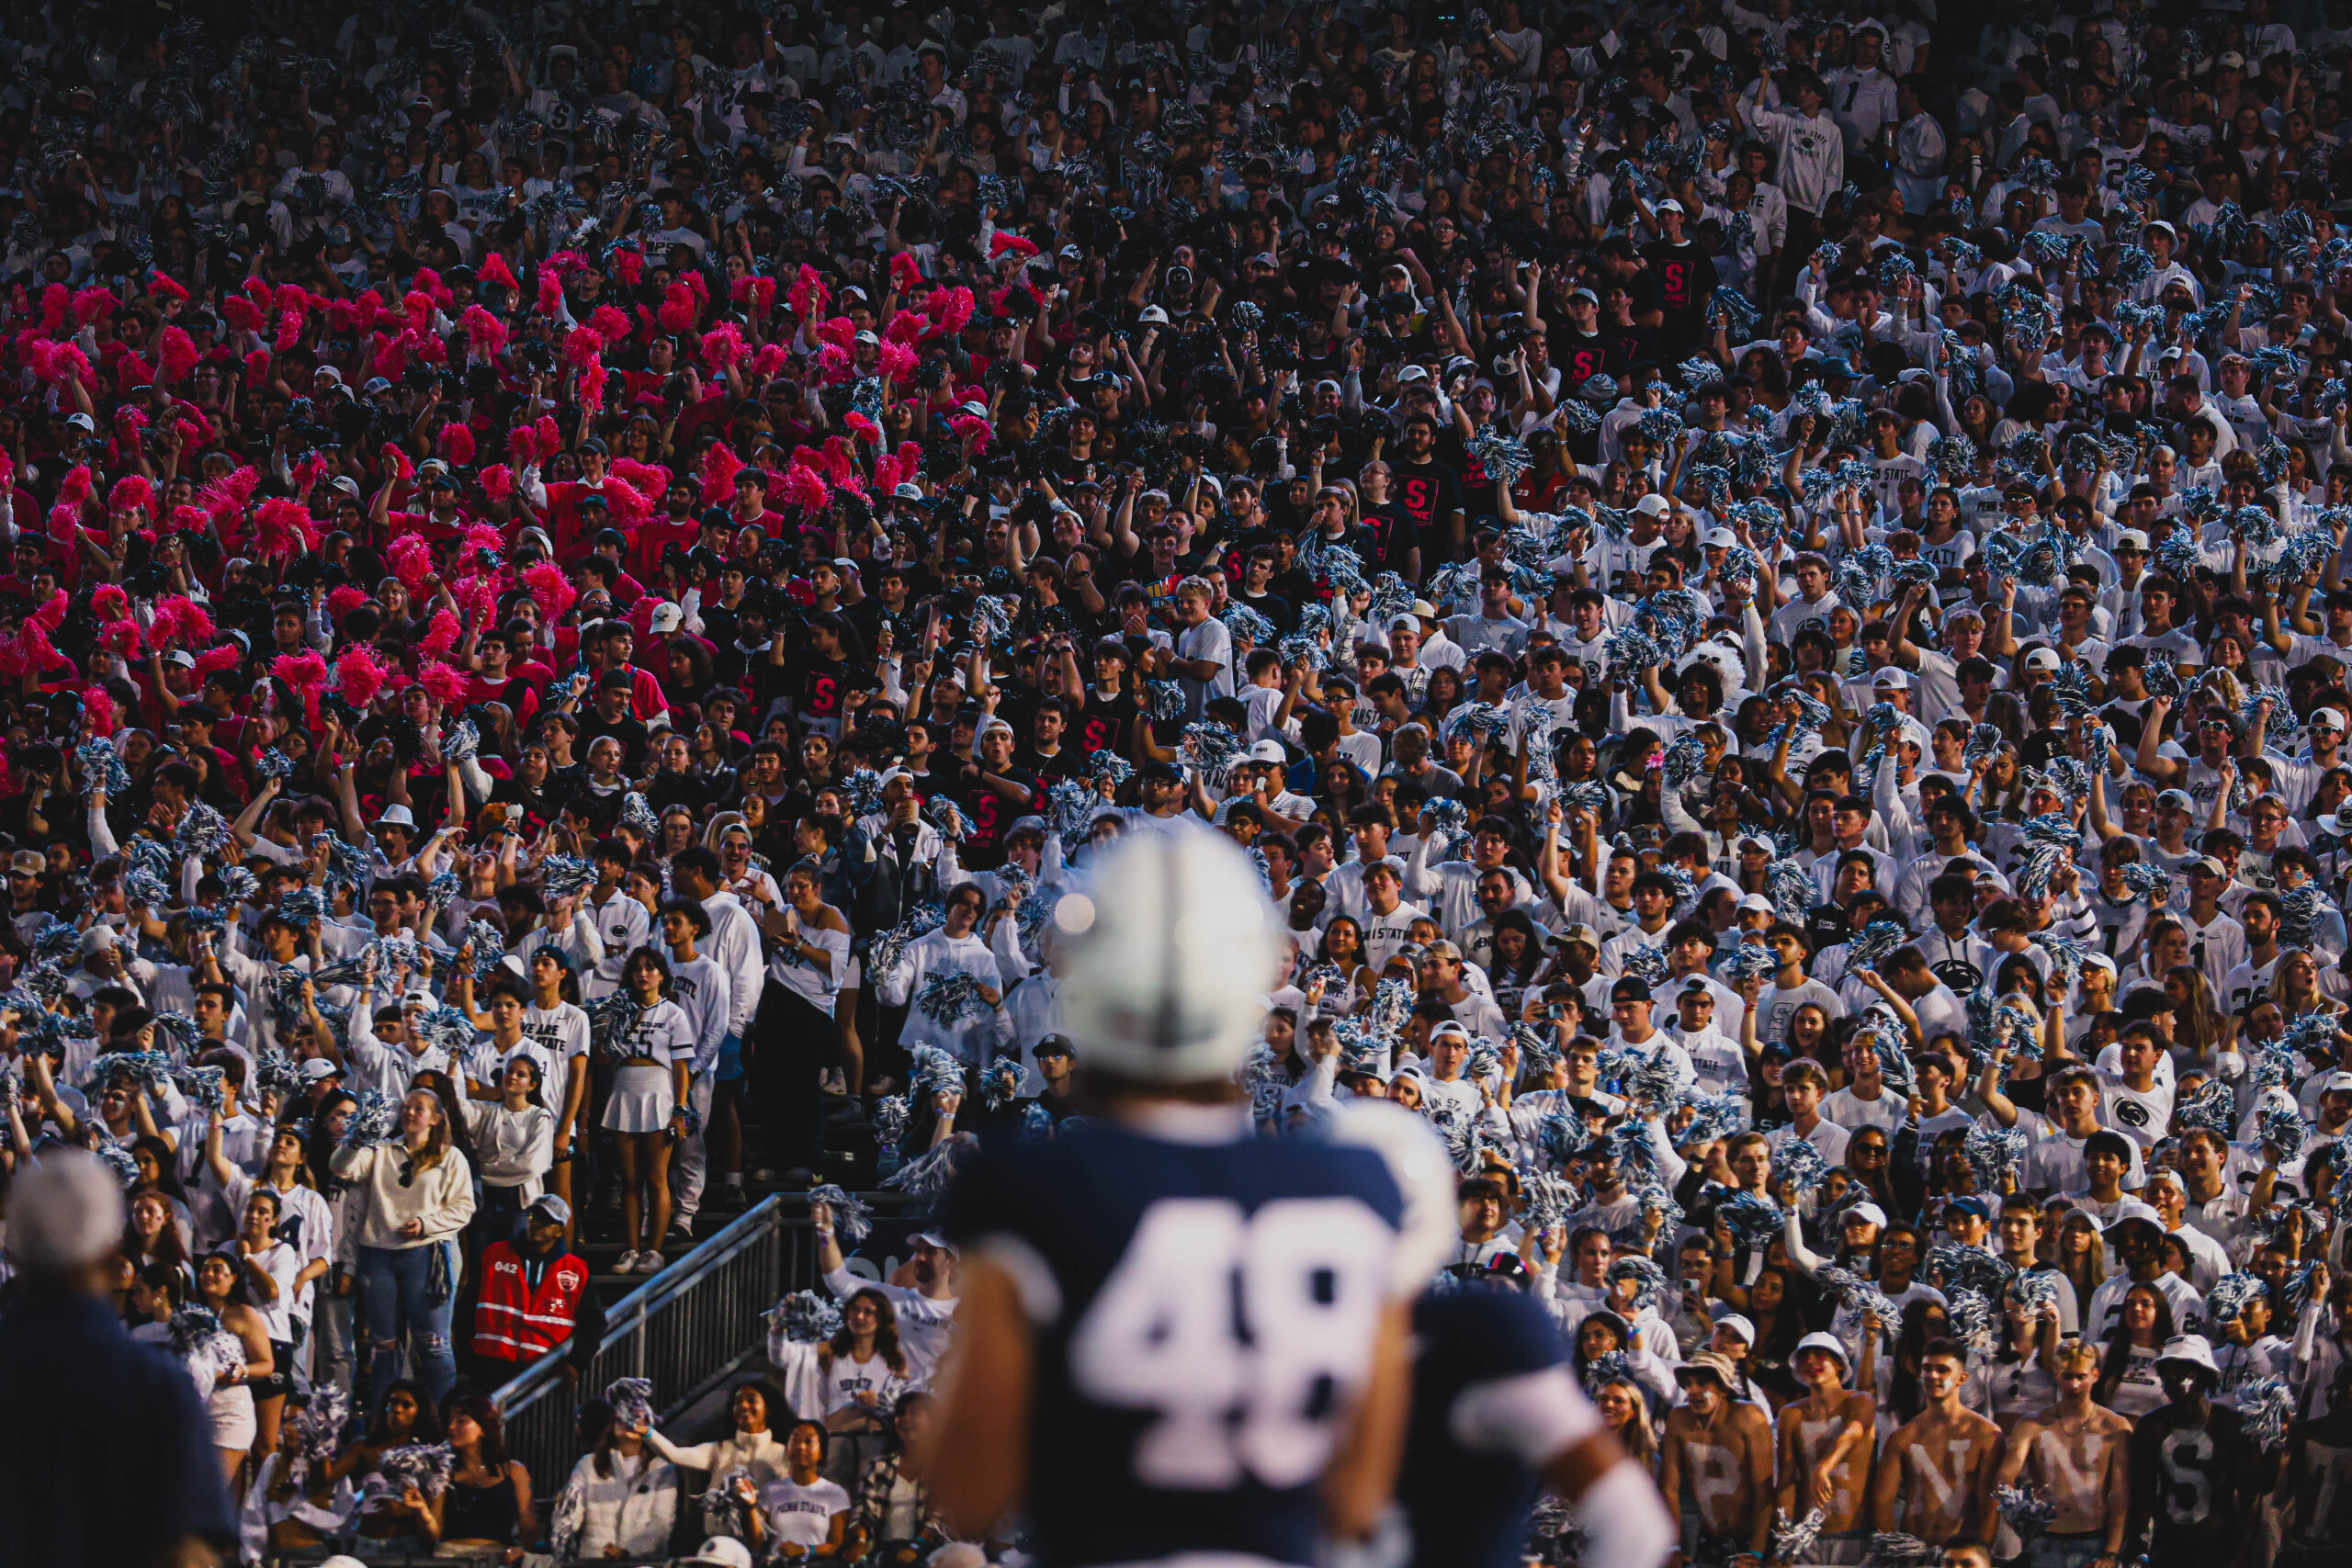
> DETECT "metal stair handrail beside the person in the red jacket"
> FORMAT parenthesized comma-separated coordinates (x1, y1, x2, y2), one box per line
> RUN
(492, 1194, 816, 1495)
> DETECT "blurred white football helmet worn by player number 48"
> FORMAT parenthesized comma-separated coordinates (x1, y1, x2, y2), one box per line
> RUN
(1054, 829, 1280, 1084)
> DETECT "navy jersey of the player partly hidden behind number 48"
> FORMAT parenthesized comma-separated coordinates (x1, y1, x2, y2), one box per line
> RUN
(1397, 1286, 1601, 1568)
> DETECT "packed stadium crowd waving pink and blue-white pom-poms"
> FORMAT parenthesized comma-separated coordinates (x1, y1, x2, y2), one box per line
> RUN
(0, 0, 2352, 1568)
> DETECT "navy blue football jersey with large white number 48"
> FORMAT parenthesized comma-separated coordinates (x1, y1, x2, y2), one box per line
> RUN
(941, 1123, 1411, 1568)
